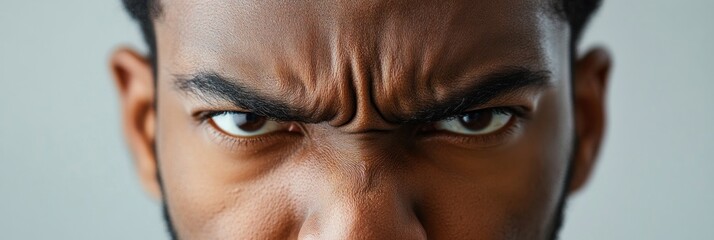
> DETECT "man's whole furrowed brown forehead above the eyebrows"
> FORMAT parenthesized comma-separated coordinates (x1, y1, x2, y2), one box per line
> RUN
(156, 0, 567, 122)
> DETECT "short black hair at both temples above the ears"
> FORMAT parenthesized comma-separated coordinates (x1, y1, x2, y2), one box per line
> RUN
(122, 0, 602, 67)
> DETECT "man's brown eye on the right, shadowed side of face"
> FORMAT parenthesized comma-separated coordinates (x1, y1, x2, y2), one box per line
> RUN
(436, 108, 513, 135)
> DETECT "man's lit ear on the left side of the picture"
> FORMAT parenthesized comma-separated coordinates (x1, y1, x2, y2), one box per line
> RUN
(109, 49, 161, 199)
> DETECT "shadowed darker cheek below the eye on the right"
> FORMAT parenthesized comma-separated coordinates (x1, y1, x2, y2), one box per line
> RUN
(415, 83, 573, 237)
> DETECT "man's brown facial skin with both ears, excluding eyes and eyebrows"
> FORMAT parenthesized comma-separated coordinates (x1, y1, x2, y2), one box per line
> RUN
(111, 0, 610, 239)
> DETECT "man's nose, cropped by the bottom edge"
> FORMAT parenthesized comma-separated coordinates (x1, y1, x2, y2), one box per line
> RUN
(300, 134, 426, 239)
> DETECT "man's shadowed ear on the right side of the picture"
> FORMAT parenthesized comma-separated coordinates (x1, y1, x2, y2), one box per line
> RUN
(568, 48, 612, 194)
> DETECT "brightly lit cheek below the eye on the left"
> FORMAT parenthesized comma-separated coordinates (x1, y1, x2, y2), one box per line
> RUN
(156, 86, 304, 239)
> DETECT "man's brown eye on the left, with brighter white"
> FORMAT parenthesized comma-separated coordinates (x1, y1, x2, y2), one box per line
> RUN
(209, 111, 281, 137)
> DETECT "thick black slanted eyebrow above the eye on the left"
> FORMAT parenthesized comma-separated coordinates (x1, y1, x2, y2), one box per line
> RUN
(174, 72, 316, 122)
